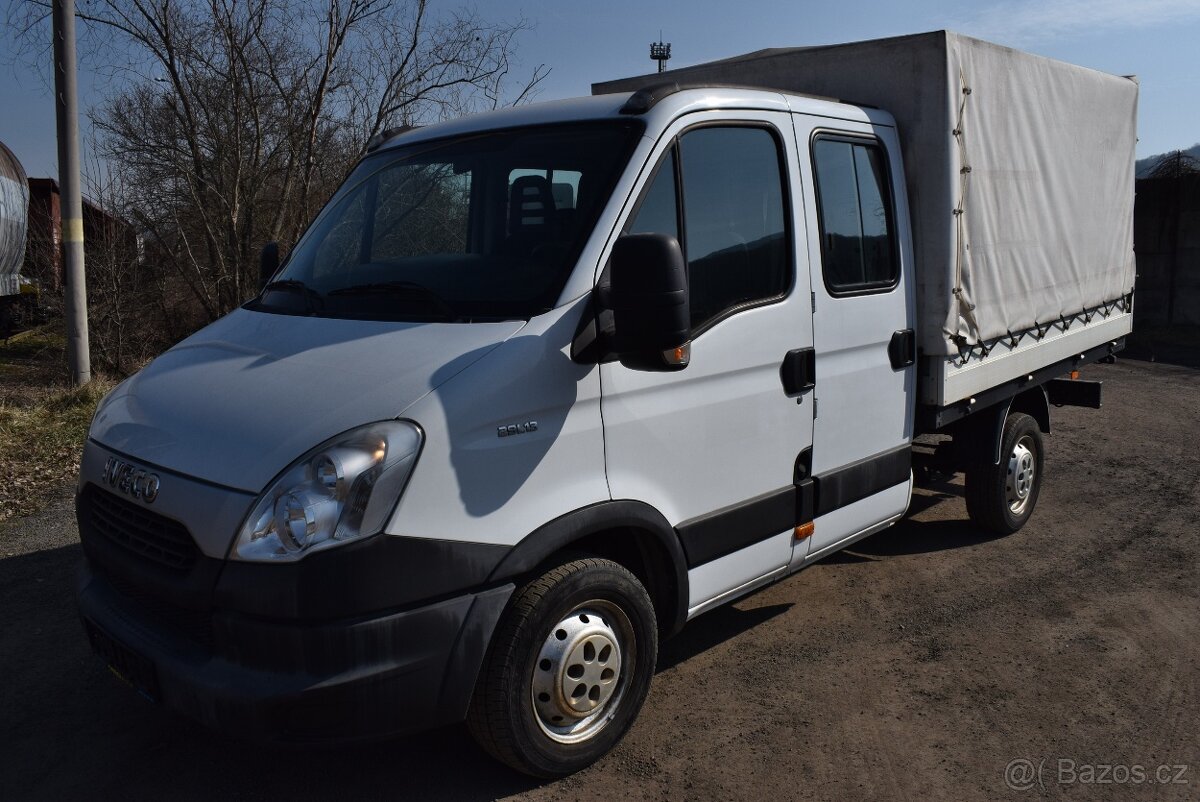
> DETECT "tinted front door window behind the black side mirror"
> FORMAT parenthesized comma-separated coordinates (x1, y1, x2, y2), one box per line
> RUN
(625, 126, 792, 333)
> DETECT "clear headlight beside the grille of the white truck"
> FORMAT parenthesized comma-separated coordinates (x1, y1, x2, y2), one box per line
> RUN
(233, 420, 424, 562)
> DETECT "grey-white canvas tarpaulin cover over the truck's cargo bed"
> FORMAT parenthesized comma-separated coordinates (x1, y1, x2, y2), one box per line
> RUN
(593, 31, 1138, 354)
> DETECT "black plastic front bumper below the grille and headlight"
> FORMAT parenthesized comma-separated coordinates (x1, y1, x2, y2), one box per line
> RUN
(78, 562, 512, 742)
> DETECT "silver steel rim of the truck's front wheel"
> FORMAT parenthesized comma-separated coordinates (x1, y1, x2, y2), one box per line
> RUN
(529, 599, 637, 743)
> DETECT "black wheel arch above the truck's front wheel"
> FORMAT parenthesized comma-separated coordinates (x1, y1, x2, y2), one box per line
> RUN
(488, 499, 688, 636)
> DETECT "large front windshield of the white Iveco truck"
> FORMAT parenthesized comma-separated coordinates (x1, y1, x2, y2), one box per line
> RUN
(251, 120, 642, 322)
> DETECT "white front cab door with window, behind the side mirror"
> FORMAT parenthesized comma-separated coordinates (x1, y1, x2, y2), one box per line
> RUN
(601, 112, 812, 611)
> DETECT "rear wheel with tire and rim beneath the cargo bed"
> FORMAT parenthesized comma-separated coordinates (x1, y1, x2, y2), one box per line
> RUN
(966, 412, 1045, 534)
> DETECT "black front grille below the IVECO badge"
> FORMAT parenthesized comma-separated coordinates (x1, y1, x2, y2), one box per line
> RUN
(83, 485, 198, 573)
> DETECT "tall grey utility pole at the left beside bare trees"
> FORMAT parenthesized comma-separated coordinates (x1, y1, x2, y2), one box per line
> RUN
(54, 0, 91, 387)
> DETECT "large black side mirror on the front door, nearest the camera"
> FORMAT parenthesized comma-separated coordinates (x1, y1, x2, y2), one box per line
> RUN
(608, 234, 691, 371)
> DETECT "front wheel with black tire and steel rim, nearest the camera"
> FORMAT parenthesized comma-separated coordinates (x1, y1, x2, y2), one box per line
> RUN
(467, 557, 658, 778)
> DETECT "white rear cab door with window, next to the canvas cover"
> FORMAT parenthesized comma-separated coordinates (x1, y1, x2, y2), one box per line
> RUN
(796, 115, 916, 556)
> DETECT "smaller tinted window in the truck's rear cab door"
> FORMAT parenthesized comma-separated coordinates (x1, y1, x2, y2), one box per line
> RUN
(812, 138, 900, 295)
